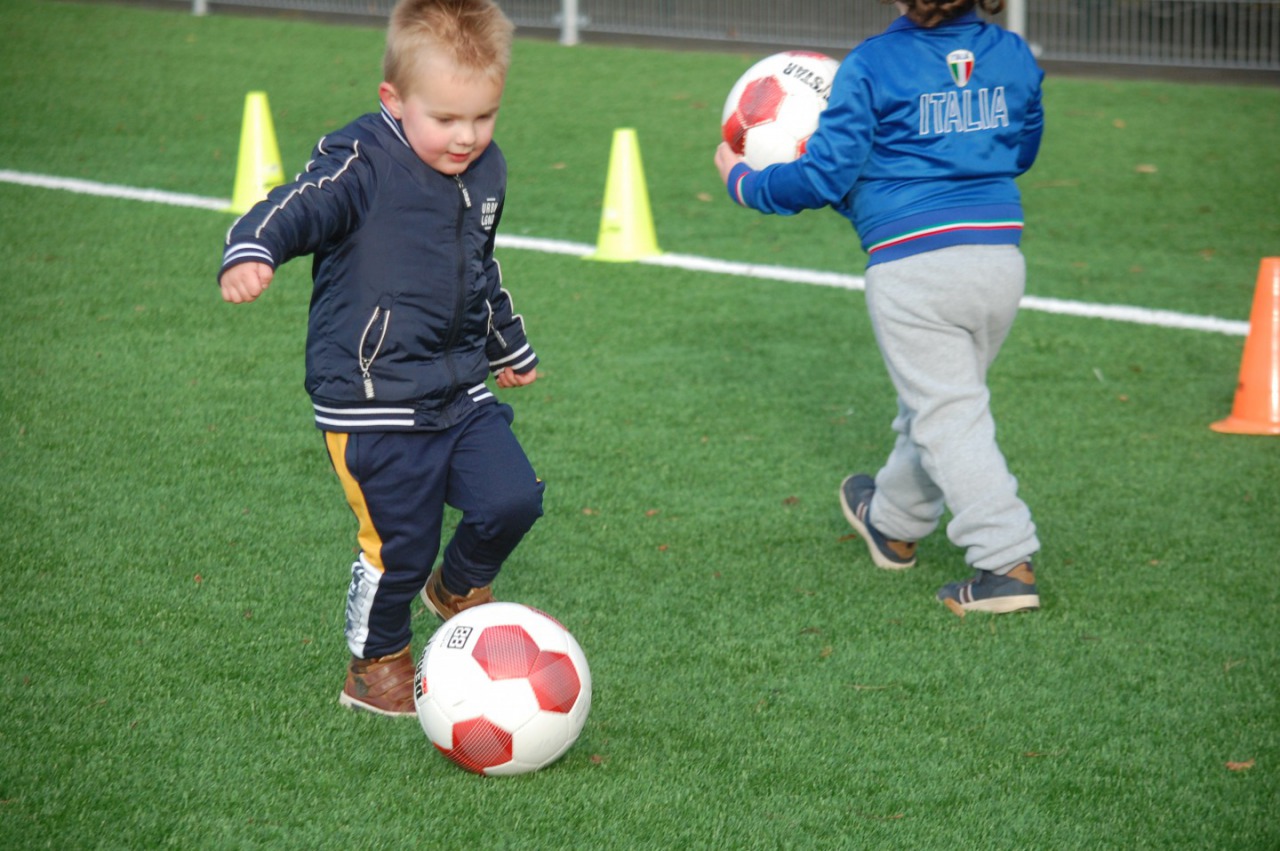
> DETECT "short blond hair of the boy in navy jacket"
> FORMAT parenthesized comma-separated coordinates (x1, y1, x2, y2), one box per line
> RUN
(383, 0, 516, 92)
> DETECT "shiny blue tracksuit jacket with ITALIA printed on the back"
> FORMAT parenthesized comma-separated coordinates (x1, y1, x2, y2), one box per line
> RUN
(728, 12, 1044, 265)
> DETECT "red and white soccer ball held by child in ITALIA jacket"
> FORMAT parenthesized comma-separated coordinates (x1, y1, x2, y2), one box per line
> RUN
(721, 50, 840, 169)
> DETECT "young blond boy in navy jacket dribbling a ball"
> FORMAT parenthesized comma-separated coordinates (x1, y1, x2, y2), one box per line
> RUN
(219, 0, 543, 717)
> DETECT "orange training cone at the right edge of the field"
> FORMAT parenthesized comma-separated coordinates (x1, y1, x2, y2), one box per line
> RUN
(1210, 257, 1280, 434)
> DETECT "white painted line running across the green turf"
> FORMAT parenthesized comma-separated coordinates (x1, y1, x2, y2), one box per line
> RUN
(0, 169, 1249, 337)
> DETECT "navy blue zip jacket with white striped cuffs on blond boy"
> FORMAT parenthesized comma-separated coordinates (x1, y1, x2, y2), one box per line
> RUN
(221, 109, 538, 431)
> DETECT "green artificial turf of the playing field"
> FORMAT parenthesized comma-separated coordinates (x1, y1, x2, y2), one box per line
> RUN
(0, 0, 1280, 850)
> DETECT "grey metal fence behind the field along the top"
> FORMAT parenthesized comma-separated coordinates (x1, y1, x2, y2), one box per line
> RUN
(189, 0, 1280, 72)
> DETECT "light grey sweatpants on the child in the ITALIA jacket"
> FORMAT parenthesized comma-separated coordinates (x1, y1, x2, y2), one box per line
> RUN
(867, 246, 1039, 573)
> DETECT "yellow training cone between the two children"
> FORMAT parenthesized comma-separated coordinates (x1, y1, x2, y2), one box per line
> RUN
(586, 128, 662, 262)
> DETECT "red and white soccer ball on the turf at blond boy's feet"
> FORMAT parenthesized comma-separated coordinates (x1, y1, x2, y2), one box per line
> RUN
(413, 603, 591, 775)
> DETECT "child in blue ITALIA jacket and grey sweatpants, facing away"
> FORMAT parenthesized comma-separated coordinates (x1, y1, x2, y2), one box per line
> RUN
(716, 0, 1043, 616)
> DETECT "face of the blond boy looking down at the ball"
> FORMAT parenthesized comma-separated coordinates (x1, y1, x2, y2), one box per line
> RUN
(378, 56, 503, 174)
